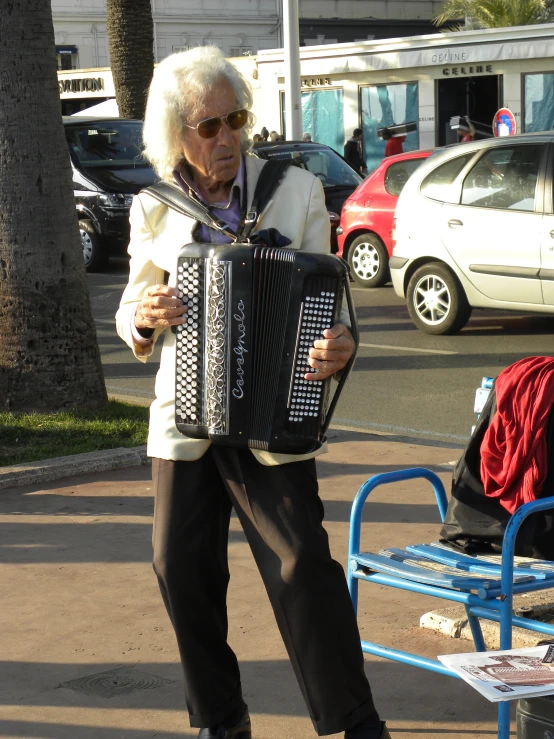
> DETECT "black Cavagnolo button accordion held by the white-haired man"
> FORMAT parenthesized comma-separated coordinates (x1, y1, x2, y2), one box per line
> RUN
(175, 243, 357, 454)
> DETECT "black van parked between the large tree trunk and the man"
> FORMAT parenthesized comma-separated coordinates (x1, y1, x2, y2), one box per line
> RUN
(63, 116, 158, 272)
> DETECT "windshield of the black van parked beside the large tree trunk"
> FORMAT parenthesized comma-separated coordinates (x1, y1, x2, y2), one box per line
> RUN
(65, 121, 147, 167)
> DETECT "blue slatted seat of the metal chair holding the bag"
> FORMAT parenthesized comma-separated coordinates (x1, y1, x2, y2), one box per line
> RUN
(351, 542, 554, 598)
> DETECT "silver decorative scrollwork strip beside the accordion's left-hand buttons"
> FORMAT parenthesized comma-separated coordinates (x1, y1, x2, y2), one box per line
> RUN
(206, 262, 229, 434)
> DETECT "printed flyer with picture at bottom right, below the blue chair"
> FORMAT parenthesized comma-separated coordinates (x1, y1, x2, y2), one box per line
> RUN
(438, 644, 554, 703)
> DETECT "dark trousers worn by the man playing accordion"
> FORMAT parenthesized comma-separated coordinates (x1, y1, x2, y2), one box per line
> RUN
(149, 446, 375, 736)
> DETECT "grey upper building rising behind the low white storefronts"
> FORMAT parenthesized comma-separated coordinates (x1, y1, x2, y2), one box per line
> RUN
(52, 0, 442, 70)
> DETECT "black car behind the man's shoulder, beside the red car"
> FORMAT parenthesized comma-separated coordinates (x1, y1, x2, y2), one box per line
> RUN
(252, 141, 362, 254)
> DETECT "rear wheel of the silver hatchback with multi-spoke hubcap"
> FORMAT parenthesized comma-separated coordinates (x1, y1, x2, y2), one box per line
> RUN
(407, 262, 471, 335)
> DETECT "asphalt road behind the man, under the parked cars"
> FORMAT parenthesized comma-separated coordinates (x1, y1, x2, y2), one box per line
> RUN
(88, 261, 554, 444)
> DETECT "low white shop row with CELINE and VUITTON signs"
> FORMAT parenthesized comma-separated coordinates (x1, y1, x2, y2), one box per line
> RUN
(58, 22, 554, 176)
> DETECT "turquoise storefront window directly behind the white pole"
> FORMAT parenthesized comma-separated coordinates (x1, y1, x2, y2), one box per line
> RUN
(283, 90, 344, 156)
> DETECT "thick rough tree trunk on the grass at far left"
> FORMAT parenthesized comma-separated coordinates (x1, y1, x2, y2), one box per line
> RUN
(0, 0, 106, 411)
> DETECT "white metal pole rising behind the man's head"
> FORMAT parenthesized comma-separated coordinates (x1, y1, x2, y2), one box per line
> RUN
(283, 0, 302, 141)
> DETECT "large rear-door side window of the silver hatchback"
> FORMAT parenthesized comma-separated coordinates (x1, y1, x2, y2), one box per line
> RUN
(462, 144, 543, 211)
